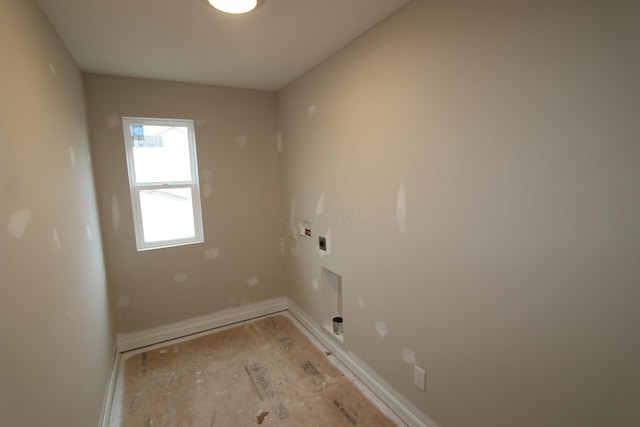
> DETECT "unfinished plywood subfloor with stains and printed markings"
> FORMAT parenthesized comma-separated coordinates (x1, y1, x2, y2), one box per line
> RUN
(109, 314, 404, 427)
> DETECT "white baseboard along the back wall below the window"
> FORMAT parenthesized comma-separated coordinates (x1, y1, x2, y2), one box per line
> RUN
(117, 297, 287, 352)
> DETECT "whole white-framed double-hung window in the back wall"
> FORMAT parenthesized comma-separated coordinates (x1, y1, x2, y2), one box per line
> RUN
(122, 117, 204, 251)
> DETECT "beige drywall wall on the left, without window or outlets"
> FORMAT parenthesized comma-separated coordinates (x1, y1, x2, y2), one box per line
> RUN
(0, 0, 115, 427)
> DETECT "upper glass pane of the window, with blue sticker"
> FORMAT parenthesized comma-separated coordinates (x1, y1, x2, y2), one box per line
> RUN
(130, 124, 191, 184)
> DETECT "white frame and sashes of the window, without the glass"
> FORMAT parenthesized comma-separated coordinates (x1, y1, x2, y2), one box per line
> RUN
(122, 117, 204, 251)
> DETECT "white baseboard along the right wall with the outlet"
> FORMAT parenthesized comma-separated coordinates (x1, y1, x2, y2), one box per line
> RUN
(287, 300, 438, 427)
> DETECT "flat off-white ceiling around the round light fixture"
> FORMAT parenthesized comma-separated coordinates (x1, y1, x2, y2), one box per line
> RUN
(36, 0, 409, 90)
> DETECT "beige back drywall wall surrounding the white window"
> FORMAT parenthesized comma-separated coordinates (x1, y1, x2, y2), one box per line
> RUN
(85, 74, 283, 332)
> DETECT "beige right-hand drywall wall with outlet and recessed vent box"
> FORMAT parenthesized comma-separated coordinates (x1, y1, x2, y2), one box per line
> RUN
(278, 0, 640, 427)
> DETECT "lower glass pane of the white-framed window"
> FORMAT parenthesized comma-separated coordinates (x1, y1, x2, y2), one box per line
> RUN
(140, 188, 195, 243)
